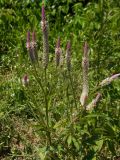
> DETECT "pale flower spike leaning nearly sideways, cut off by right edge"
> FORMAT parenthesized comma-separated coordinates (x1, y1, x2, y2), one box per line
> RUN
(99, 73, 120, 87)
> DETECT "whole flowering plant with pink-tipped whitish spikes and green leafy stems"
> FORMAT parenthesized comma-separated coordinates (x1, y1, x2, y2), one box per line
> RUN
(22, 5, 120, 159)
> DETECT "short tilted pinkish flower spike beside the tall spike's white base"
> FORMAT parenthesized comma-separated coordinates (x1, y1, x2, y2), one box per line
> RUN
(86, 93, 102, 111)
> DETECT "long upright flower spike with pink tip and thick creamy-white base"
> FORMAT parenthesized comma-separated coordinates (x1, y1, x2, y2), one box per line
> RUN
(80, 42, 89, 107)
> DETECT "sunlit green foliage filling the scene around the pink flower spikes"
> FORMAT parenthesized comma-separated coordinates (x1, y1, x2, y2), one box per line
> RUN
(0, 0, 120, 160)
